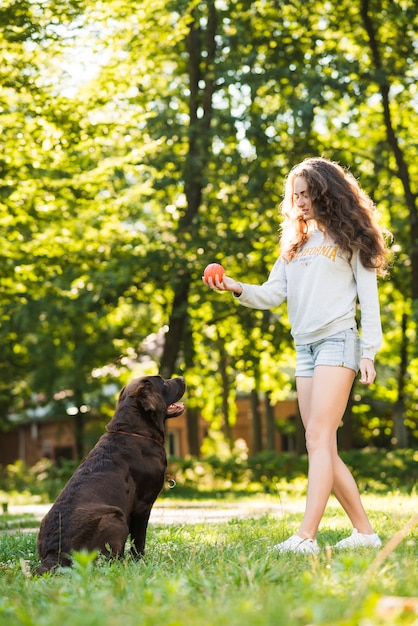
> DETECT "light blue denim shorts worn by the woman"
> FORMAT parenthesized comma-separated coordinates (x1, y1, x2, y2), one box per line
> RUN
(295, 328, 361, 376)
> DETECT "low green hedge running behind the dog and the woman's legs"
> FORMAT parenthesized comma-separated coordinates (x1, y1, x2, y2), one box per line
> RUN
(0, 449, 418, 502)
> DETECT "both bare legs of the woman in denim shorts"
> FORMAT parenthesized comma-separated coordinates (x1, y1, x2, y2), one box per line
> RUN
(296, 365, 373, 538)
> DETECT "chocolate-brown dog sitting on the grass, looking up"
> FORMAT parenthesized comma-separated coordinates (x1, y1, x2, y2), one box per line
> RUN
(37, 376, 186, 574)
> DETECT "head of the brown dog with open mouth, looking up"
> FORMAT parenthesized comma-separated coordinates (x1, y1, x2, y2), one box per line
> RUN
(107, 376, 186, 431)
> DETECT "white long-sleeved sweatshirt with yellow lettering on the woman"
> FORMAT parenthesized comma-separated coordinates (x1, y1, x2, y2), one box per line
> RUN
(238, 230, 382, 359)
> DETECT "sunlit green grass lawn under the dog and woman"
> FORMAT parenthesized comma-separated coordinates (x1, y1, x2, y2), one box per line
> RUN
(0, 494, 418, 626)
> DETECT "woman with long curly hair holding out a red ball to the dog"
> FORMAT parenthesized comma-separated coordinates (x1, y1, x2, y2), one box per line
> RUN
(203, 158, 387, 553)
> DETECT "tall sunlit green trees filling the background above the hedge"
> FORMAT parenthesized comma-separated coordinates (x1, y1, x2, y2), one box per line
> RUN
(0, 0, 418, 479)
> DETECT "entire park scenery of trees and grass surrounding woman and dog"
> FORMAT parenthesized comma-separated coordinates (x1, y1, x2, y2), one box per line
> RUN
(0, 0, 418, 626)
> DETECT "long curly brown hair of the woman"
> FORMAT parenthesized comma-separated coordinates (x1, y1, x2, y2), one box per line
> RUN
(280, 157, 389, 275)
